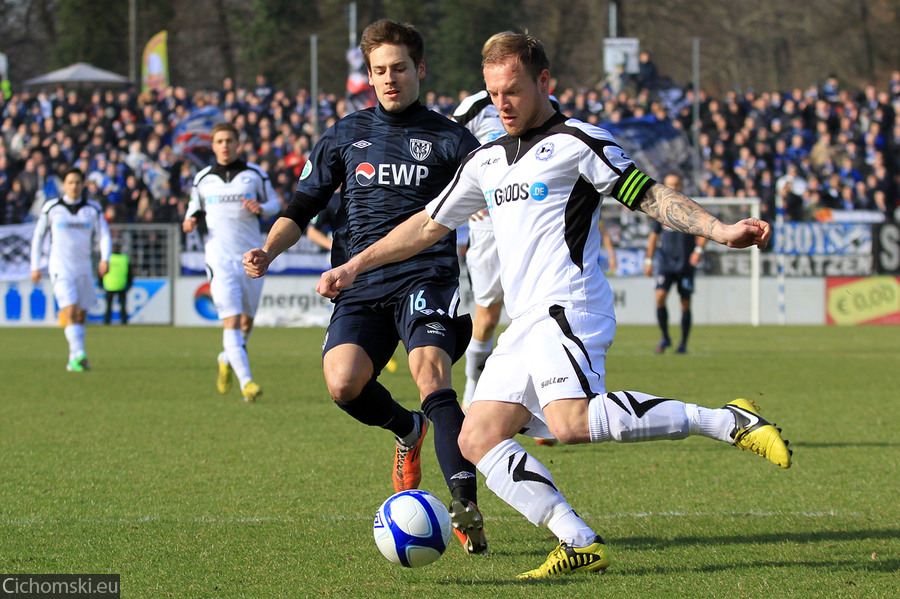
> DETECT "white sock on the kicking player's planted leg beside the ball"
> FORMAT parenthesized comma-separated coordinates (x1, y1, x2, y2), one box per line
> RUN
(477, 439, 572, 534)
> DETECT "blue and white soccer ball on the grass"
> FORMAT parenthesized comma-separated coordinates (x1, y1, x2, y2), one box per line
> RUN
(373, 489, 453, 568)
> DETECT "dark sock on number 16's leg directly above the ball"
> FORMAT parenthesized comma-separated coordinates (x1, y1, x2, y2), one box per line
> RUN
(422, 389, 477, 503)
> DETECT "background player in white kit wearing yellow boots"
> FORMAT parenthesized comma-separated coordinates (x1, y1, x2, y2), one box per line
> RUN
(182, 123, 281, 402)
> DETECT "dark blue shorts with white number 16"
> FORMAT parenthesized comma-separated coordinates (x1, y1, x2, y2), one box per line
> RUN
(322, 285, 472, 376)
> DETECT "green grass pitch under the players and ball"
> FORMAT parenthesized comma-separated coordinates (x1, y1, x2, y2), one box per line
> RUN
(0, 326, 900, 599)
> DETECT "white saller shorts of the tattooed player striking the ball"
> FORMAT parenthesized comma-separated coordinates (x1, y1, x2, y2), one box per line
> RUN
(472, 305, 616, 439)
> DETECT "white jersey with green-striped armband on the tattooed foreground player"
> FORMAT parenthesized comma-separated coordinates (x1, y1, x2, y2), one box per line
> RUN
(426, 113, 654, 318)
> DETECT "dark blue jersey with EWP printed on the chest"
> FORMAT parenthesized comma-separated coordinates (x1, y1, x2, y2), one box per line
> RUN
(295, 102, 479, 300)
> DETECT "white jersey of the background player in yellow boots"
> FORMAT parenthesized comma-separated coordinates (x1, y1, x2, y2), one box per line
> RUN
(185, 160, 281, 265)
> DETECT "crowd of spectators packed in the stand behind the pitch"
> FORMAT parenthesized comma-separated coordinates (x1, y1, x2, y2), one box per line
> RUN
(0, 65, 900, 230)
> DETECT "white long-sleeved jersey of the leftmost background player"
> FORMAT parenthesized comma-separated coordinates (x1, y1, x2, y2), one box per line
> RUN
(31, 197, 112, 278)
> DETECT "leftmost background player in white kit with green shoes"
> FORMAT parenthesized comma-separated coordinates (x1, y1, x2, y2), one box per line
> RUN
(31, 167, 112, 372)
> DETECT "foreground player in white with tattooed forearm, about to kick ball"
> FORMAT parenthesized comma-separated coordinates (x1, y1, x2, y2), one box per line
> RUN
(317, 34, 791, 578)
